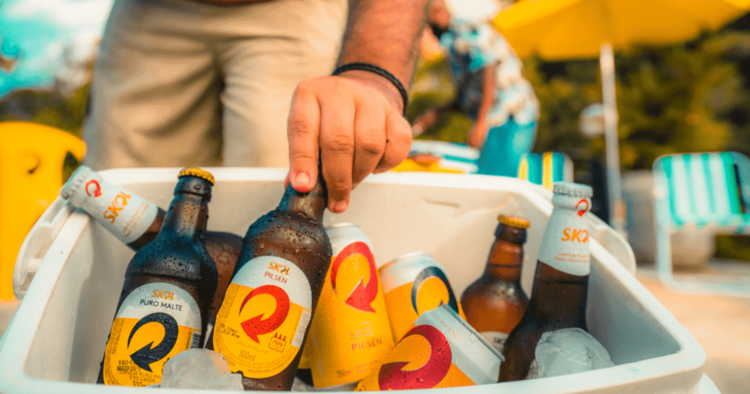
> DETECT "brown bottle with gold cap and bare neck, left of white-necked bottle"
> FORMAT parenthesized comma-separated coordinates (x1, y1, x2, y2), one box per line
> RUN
(461, 215, 529, 352)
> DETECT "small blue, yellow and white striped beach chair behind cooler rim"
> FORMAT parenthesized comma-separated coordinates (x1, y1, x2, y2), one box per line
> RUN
(518, 152, 573, 190)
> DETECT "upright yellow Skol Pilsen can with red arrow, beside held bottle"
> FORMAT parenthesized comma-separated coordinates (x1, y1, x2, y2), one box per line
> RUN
(305, 223, 400, 390)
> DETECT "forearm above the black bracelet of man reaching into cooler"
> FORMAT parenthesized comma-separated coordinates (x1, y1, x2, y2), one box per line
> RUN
(338, 0, 429, 93)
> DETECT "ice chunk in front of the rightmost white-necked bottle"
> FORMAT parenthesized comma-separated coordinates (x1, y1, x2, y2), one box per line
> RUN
(526, 328, 615, 379)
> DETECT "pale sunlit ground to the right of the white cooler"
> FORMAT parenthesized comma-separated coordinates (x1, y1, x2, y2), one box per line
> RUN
(637, 267, 750, 394)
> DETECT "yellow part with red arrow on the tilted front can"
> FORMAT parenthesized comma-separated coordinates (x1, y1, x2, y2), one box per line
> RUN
(356, 325, 475, 391)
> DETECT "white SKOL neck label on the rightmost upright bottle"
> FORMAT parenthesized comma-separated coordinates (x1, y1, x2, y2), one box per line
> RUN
(539, 196, 591, 276)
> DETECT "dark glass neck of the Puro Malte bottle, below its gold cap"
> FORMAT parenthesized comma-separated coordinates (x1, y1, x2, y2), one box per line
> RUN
(159, 192, 208, 239)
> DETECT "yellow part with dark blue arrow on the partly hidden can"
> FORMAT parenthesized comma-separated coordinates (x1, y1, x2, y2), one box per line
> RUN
(385, 276, 466, 341)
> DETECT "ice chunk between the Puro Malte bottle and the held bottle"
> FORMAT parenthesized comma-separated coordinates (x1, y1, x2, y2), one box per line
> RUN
(160, 349, 243, 391)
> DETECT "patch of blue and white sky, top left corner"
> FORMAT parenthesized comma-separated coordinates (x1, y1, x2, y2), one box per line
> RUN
(0, 0, 112, 97)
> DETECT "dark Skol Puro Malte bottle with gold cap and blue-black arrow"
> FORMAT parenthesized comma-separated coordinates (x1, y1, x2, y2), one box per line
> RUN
(99, 168, 218, 386)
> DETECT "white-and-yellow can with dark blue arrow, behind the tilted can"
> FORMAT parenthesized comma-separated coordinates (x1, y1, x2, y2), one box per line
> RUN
(380, 252, 466, 341)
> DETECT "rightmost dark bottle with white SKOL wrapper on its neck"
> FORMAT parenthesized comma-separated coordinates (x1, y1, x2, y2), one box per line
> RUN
(500, 182, 592, 382)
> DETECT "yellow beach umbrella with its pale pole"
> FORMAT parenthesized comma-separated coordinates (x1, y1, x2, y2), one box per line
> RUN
(493, 0, 750, 235)
